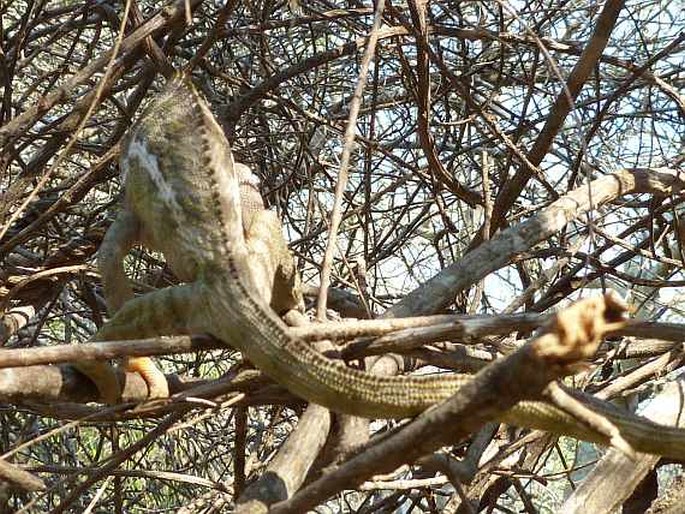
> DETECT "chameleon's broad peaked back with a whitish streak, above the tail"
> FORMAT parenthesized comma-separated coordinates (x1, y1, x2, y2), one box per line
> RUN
(121, 79, 242, 281)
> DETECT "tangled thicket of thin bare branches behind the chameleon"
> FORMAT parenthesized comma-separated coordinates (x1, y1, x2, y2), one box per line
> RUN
(0, 0, 685, 512)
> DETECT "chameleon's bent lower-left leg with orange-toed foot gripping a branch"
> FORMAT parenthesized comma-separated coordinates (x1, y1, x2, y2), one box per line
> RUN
(74, 284, 204, 403)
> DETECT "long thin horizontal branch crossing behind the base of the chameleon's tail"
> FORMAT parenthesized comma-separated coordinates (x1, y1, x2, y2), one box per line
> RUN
(0, 313, 685, 374)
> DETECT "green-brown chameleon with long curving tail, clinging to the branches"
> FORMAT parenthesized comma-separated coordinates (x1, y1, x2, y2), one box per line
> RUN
(76, 77, 685, 459)
